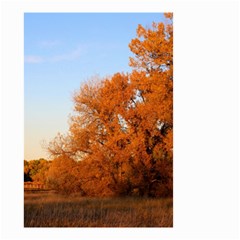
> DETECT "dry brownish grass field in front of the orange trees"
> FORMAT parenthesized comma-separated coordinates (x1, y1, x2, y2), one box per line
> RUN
(24, 192, 173, 227)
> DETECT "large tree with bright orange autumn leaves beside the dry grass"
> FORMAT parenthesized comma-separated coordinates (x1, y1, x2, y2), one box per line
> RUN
(49, 14, 173, 196)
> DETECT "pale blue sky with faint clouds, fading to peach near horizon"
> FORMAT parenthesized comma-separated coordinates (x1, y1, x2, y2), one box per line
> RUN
(24, 13, 166, 160)
